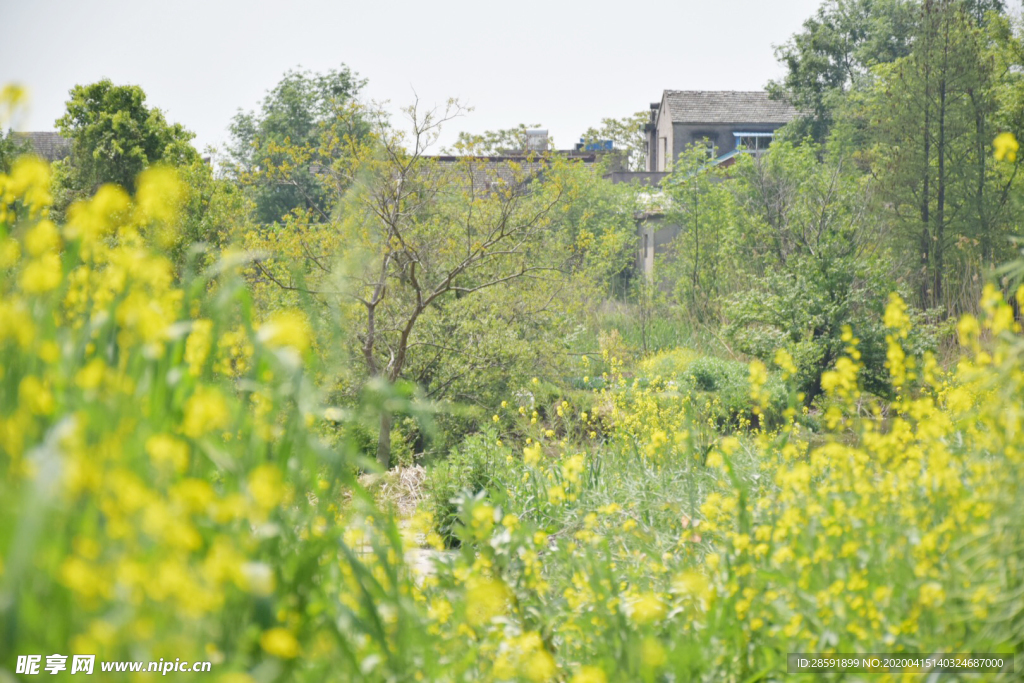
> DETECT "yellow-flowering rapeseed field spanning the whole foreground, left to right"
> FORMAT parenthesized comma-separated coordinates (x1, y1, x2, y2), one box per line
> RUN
(6, 147, 1024, 683)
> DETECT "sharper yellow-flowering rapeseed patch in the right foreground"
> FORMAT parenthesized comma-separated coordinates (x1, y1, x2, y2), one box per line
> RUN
(428, 293, 1024, 681)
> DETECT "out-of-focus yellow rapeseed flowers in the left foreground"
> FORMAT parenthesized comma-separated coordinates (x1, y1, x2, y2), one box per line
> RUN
(0, 148, 452, 680)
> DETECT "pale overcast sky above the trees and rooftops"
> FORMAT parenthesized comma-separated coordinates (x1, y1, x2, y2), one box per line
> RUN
(0, 0, 820, 152)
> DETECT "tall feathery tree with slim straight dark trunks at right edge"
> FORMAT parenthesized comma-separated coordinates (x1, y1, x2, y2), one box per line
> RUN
(868, 0, 1021, 310)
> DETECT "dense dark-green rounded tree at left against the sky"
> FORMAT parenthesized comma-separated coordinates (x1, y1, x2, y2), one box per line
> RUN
(56, 79, 199, 202)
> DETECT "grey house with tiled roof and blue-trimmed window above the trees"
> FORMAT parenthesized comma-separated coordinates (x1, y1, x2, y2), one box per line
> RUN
(644, 90, 798, 173)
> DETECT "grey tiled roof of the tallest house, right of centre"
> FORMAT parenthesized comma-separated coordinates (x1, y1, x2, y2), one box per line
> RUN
(664, 90, 798, 124)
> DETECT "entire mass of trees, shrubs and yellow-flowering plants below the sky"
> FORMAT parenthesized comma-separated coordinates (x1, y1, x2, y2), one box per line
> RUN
(6, 0, 1024, 683)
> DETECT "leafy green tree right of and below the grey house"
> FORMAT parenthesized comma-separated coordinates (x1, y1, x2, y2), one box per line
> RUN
(725, 141, 909, 401)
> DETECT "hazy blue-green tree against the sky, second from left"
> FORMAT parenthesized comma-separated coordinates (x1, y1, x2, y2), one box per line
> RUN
(227, 66, 367, 223)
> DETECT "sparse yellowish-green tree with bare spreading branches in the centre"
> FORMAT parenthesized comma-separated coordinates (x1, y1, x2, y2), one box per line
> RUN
(244, 101, 632, 467)
